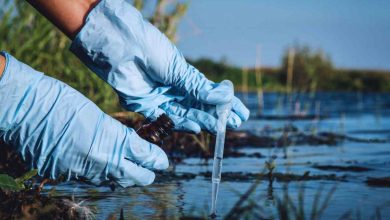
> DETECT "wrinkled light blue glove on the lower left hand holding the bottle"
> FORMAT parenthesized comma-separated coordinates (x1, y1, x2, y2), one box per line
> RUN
(0, 53, 168, 187)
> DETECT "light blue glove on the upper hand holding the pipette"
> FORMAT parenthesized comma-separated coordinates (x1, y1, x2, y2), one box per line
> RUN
(70, 0, 249, 133)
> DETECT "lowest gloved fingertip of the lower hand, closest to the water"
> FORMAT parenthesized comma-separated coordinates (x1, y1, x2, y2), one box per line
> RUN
(110, 158, 156, 187)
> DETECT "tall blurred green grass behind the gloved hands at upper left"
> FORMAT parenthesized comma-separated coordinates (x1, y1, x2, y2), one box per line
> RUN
(0, 0, 187, 113)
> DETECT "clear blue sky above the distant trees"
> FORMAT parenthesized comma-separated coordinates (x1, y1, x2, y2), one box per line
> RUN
(178, 0, 390, 69)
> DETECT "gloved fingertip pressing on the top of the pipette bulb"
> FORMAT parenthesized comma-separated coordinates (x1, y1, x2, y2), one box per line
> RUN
(199, 80, 234, 105)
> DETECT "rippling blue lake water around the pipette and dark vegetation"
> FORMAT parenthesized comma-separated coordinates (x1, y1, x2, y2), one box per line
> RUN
(48, 93, 390, 219)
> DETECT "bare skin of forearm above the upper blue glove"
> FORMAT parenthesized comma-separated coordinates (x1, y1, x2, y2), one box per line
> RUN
(27, 0, 99, 39)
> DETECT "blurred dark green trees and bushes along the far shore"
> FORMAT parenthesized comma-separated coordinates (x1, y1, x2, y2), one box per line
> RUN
(190, 45, 390, 92)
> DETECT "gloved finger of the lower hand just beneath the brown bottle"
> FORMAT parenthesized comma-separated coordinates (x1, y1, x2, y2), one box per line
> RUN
(125, 128, 169, 170)
